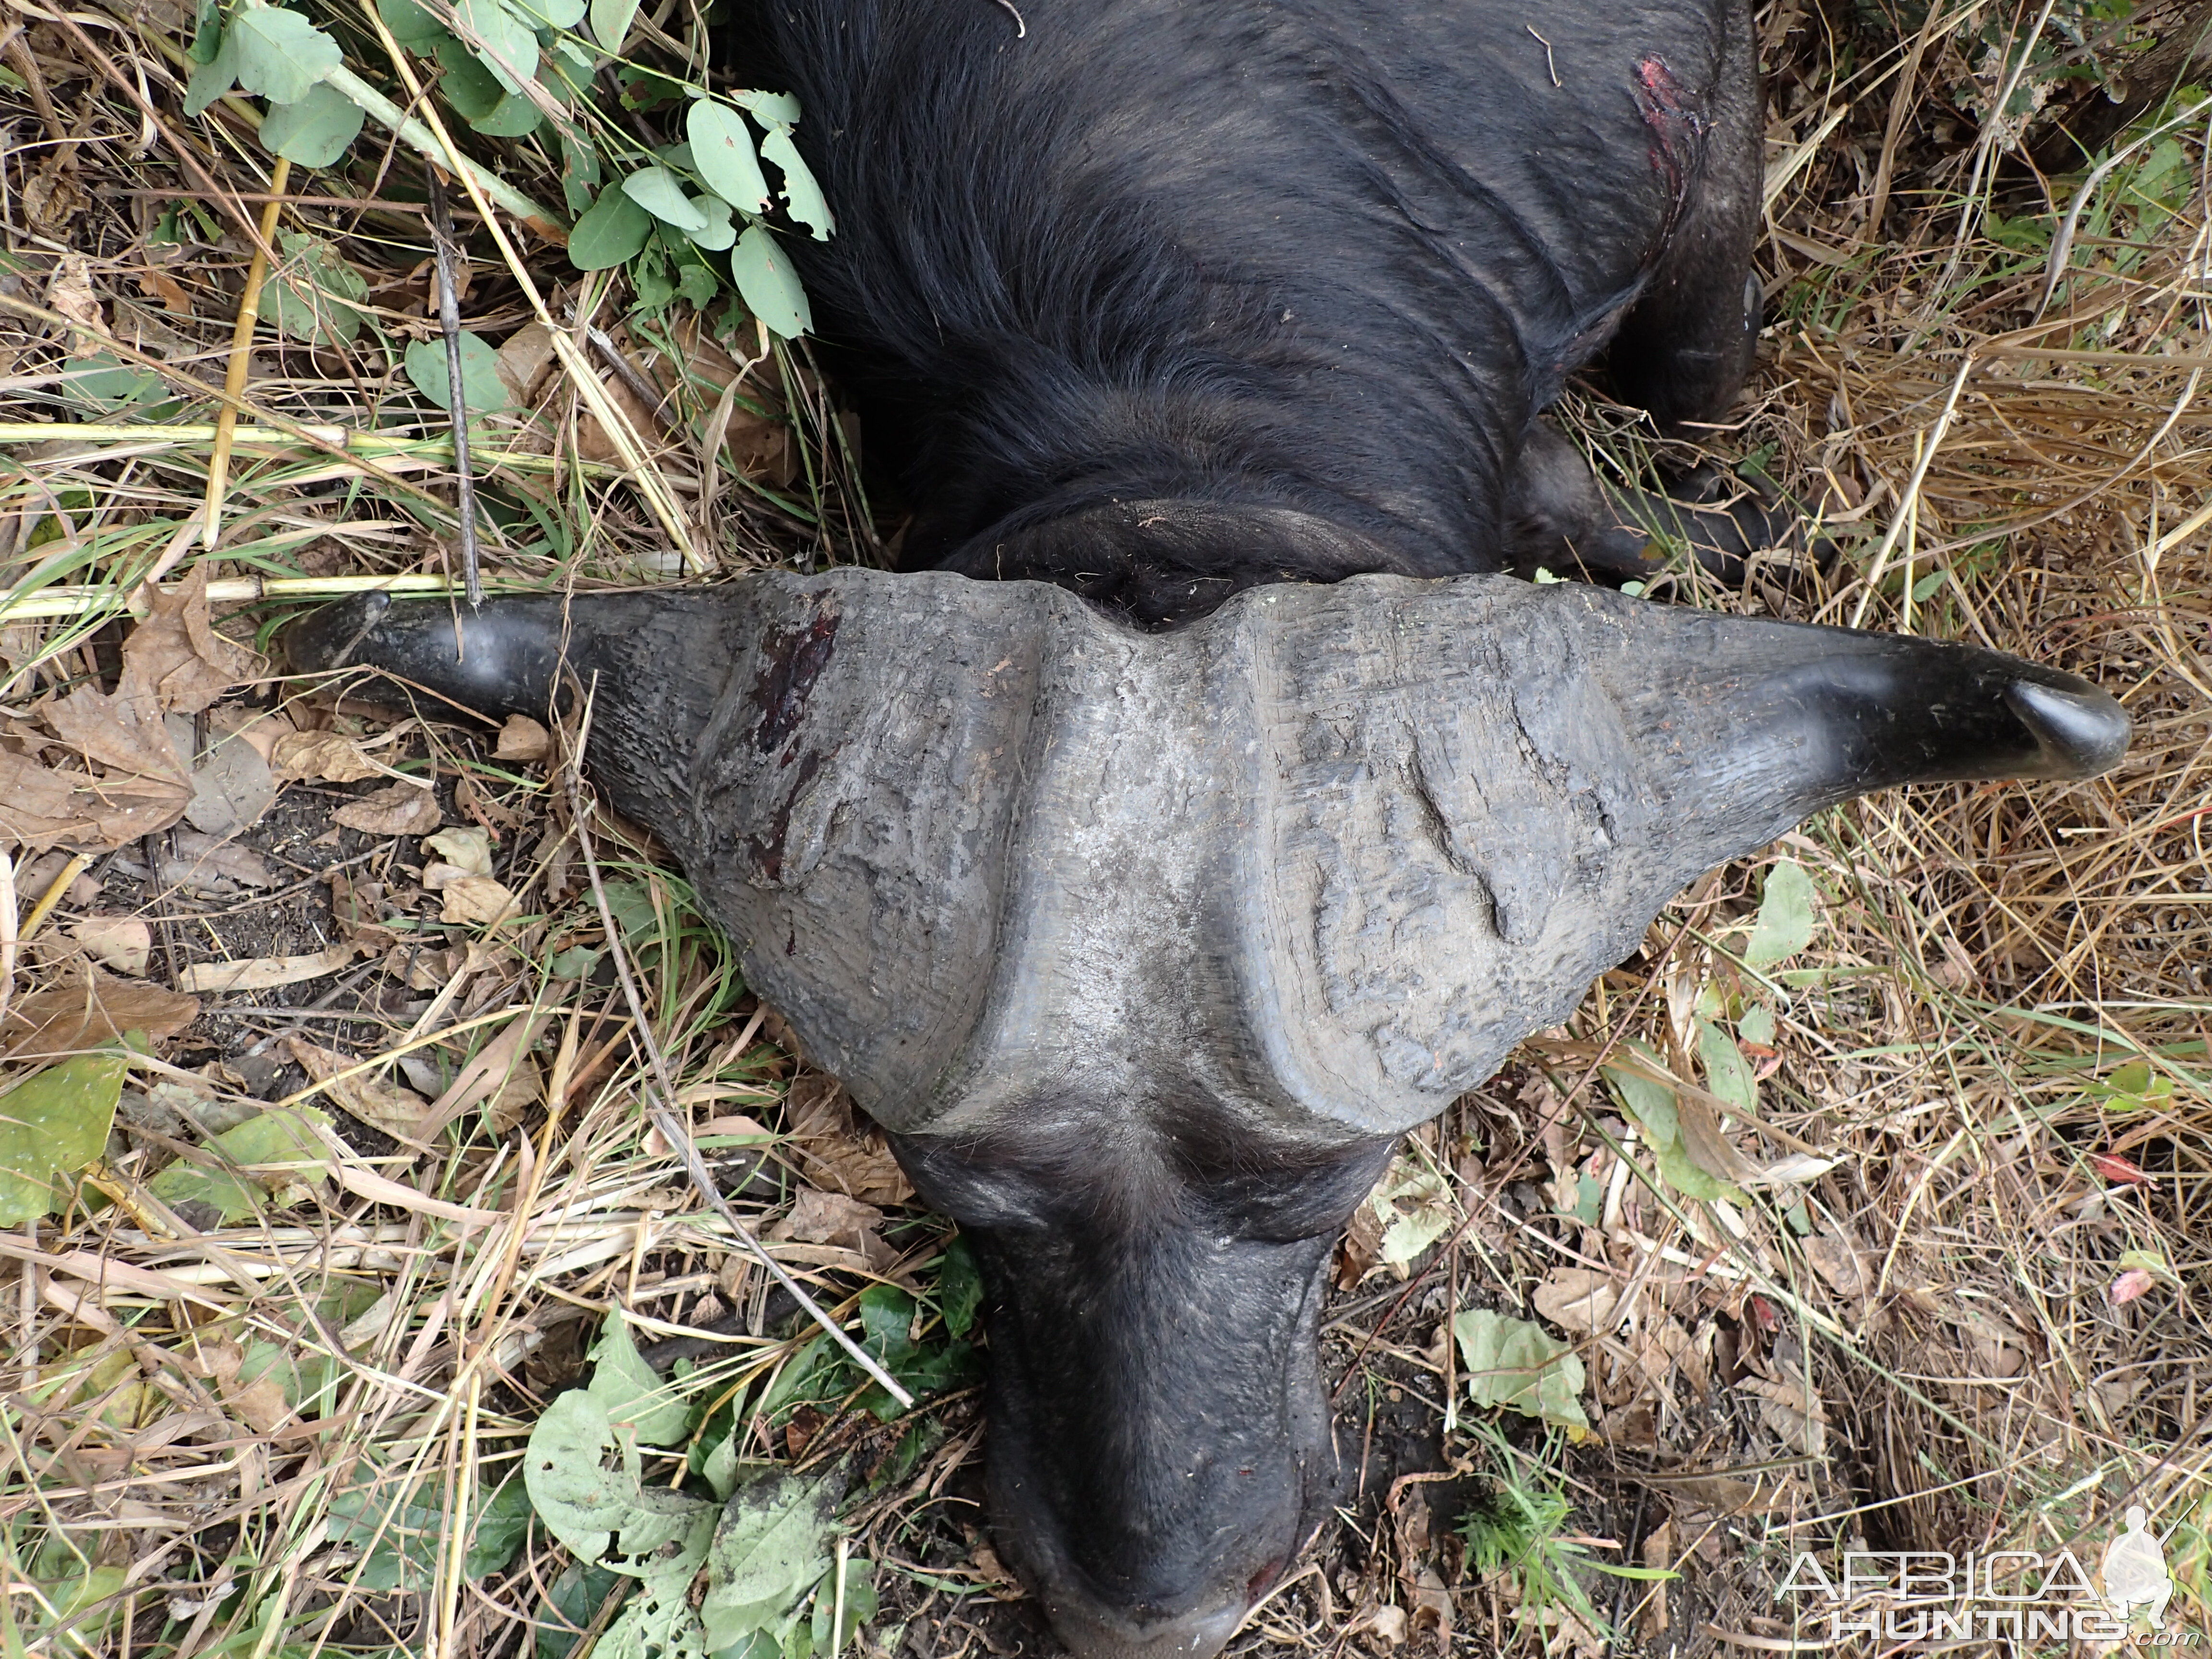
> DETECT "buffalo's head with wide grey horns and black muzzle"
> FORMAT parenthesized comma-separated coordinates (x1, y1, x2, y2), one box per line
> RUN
(294, 571, 2128, 1659)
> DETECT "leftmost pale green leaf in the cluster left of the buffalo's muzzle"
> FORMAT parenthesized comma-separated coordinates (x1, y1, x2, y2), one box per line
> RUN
(522, 1389, 714, 1577)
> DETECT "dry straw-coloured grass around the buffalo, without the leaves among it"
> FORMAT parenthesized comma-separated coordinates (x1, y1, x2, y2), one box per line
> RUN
(0, 0, 2212, 1659)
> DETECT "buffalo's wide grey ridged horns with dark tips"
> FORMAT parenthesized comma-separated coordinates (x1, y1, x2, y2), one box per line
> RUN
(294, 568, 2128, 1137)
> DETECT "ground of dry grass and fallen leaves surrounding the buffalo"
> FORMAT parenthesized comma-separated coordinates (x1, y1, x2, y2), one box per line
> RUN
(0, 0, 2212, 1659)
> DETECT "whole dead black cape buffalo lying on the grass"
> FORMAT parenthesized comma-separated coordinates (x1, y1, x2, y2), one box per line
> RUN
(294, 0, 2128, 1659)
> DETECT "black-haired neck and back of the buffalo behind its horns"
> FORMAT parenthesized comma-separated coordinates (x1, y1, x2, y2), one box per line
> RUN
(728, 0, 1741, 626)
